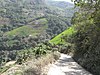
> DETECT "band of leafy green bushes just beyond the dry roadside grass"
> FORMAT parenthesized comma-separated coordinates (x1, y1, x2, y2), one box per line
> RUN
(0, 43, 54, 66)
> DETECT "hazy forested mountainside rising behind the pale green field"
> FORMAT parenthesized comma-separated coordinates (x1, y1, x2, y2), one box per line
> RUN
(0, 0, 73, 37)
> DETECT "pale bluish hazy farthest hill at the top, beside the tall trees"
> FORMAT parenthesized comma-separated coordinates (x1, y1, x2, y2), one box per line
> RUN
(48, 1, 77, 23)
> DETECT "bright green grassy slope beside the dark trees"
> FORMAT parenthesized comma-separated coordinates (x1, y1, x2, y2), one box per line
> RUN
(49, 26, 76, 44)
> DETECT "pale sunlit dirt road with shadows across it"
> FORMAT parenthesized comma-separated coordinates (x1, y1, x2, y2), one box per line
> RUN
(47, 54, 92, 75)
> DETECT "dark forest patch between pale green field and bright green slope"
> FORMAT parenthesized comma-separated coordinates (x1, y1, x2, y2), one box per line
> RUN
(46, 15, 69, 37)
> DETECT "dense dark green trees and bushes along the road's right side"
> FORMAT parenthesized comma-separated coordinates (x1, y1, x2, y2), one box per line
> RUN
(51, 0, 100, 75)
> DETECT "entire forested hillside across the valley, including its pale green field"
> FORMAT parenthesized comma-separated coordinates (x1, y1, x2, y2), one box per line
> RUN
(0, 0, 73, 50)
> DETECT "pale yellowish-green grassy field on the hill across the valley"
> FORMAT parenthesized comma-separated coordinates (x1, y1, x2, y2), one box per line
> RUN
(5, 25, 46, 38)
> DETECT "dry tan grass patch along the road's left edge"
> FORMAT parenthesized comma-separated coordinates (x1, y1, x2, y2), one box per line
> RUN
(23, 52, 60, 75)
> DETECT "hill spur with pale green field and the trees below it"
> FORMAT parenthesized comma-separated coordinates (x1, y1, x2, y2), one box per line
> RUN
(0, 19, 47, 50)
